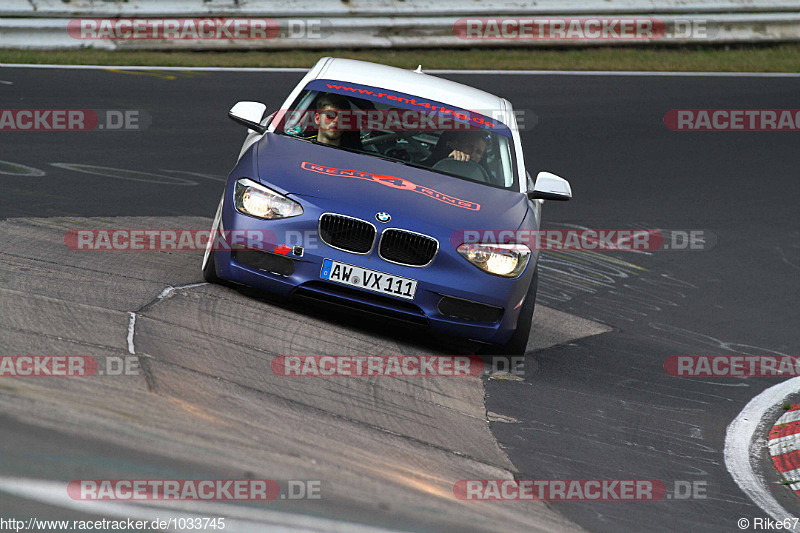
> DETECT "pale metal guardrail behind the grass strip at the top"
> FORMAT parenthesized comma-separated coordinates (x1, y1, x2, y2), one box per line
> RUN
(0, 0, 800, 50)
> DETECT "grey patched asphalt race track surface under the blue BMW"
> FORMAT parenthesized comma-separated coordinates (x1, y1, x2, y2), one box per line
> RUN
(0, 68, 800, 532)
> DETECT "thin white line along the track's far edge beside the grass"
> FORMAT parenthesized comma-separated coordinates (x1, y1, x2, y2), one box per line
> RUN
(0, 63, 800, 78)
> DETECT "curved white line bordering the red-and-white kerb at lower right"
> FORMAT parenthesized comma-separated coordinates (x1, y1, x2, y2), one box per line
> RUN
(725, 377, 800, 520)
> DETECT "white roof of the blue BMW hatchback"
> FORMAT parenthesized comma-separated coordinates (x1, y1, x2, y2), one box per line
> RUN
(316, 58, 510, 118)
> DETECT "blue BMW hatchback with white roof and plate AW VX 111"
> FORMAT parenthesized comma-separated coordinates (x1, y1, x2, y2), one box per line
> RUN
(202, 58, 571, 354)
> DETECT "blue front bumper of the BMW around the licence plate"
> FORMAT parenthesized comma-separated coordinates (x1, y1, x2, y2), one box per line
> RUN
(215, 189, 535, 344)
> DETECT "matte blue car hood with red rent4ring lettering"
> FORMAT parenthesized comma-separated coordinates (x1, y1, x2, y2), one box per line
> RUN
(253, 133, 527, 229)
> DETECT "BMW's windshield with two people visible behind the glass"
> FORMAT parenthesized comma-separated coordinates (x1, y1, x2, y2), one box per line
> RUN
(275, 84, 518, 190)
